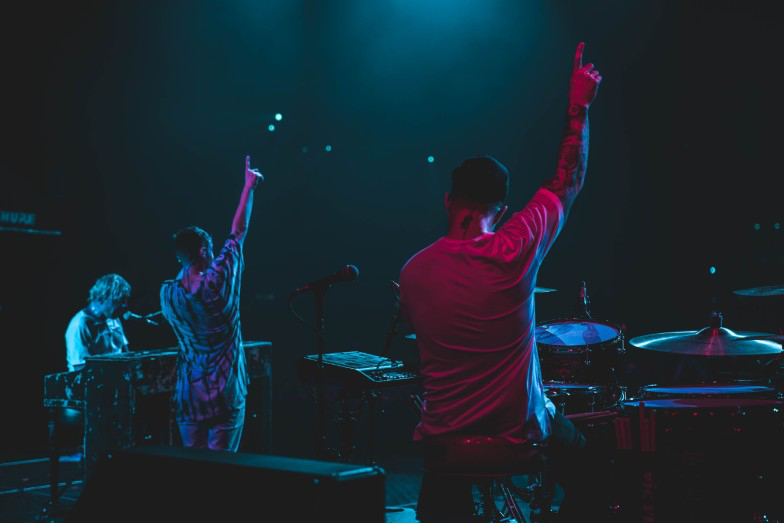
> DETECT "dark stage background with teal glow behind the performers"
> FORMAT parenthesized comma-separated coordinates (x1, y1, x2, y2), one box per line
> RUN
(0, 0, 784, 462)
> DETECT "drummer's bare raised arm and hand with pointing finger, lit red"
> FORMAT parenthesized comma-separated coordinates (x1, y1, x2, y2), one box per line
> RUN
(544, 42, 602, 216)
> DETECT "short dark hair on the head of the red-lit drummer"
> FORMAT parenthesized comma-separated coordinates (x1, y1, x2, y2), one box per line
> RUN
(449, 156, 509, 205)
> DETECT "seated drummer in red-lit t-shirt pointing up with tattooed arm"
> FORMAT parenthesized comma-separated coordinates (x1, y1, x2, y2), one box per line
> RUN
(400, 43, 601, 521)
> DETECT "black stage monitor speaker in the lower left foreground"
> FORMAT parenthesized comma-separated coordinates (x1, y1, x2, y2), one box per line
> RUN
(66, 447, 385, 523)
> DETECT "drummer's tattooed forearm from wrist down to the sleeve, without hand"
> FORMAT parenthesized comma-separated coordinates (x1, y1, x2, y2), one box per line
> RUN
(544, 104, 588, 211)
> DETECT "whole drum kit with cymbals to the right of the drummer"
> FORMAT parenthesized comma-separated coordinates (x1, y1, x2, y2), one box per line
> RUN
(536, 283, 784, 521)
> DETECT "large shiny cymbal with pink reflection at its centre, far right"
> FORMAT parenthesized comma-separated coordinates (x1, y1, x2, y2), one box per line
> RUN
(629, 327, 782, 356)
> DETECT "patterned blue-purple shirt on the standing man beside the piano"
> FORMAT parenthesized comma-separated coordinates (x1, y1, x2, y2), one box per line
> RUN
(161, 236, 248, 421)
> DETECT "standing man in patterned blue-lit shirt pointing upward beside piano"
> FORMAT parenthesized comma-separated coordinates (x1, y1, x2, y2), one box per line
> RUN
(161, 156, 264, 452)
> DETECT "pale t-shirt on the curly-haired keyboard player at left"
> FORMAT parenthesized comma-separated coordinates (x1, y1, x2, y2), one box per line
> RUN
(65, 309, 128, 371)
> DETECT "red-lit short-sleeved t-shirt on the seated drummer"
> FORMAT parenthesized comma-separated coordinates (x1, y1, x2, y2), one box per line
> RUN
(400, 189, 564, 442)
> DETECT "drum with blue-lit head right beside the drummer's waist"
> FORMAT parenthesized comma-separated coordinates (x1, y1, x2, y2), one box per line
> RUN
(536, 319, 625, 383)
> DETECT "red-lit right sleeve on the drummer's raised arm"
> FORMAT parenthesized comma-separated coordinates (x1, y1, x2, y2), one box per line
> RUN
(496, 188, 564, 261)
